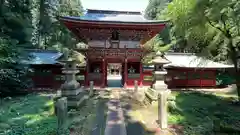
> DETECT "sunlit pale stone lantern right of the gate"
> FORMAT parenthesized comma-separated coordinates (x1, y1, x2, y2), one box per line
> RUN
(152, 52, 170, 90)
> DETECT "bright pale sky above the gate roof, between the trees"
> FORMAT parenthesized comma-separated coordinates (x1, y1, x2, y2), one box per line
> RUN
(81, 0, 148, 11)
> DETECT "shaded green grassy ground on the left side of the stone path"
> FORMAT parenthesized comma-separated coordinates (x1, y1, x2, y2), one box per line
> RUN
(0, 90, 108, 135)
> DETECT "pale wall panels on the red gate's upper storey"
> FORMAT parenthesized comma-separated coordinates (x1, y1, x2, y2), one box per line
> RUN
(88, 40, 140, 48)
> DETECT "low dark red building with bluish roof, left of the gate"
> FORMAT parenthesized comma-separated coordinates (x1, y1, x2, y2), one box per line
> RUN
(23, 49, 85, 91)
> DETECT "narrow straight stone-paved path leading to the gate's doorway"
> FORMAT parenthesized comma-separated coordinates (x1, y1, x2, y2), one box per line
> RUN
(104, 90, 127, 135)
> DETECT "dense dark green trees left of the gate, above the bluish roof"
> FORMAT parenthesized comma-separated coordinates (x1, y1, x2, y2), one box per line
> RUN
(0, 0, 82, 96)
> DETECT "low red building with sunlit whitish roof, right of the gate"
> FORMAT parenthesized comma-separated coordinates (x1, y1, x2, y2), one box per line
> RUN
(165, 53, 234, 88)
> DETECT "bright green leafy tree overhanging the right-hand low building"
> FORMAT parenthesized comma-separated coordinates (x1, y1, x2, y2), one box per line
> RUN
(167, 0, 240, 101)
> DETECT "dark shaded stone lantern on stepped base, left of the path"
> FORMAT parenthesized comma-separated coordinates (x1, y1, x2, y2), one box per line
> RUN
(61, 60, 84, 107)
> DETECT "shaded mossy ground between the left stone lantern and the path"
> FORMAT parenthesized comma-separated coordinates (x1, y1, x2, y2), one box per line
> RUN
(69, 90, 109, 135)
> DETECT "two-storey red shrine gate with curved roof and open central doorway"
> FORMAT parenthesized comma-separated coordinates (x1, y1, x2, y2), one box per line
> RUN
(60, 9, 166, 87)
